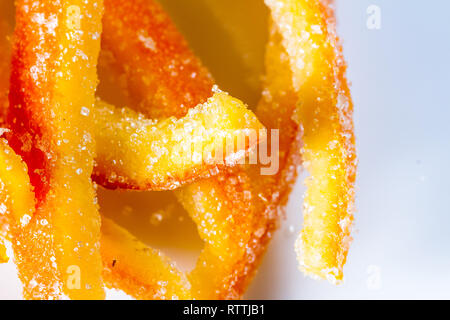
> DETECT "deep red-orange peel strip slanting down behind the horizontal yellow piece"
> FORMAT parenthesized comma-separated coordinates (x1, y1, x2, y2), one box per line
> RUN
(102, 0, 213, 118)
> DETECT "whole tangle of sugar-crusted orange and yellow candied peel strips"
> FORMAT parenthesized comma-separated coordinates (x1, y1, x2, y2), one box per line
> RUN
(0, 0, 356, 299)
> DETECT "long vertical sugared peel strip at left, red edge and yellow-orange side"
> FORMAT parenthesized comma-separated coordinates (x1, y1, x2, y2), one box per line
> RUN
(8, 0, 104, 299)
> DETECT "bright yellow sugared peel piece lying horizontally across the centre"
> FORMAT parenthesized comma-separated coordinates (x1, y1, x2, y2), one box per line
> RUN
(94, 92, 263, 190)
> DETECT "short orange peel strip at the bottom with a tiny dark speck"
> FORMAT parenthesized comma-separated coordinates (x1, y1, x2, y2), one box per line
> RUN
(101, 218, 192, 300)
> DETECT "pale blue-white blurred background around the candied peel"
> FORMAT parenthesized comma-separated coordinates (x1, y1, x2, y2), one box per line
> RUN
(0, 0, 450, 299)
